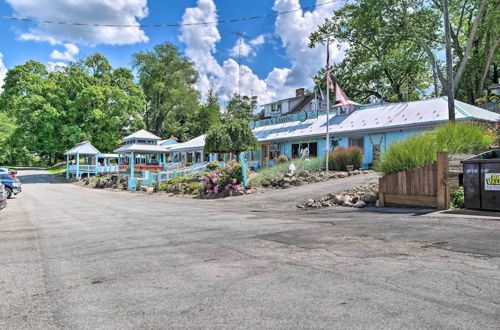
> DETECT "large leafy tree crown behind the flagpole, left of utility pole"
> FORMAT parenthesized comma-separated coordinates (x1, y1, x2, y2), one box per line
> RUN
(310, 0, 431, 102)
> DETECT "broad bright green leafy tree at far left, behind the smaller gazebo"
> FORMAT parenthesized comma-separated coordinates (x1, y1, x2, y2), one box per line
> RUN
(0, 54, 145, 165)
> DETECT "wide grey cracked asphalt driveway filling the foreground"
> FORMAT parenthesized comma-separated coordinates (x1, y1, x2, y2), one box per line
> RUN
(0, 171, 500, 329)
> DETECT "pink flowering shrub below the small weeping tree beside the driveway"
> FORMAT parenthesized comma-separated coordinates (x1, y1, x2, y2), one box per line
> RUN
(202, 163, 243, 194)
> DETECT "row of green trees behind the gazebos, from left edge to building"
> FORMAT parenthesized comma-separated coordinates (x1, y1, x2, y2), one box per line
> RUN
(0, 43, 257, 165)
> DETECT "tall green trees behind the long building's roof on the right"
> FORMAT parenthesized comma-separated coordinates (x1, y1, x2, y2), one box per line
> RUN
(309, 0, 500, 103)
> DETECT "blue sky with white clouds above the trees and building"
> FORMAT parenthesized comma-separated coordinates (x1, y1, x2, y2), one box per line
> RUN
(0, 0, 343, 104)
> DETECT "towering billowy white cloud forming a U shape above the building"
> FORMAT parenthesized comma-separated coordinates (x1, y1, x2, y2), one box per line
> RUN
(179, 0, 342, 104)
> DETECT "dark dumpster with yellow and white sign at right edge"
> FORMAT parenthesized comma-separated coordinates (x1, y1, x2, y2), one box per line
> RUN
(462, 149, 500, 211)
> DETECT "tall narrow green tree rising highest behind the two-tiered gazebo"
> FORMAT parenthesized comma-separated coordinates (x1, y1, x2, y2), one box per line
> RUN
(132, 42, 199, 136)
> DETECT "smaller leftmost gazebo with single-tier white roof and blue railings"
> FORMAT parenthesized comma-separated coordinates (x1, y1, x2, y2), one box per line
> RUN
(65, 141, 101, 180)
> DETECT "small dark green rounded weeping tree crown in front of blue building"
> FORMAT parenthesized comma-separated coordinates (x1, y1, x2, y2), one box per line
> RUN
(204, 119, 259, 154)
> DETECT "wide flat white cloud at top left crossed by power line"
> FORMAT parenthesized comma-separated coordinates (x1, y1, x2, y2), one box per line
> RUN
(6, 0, 149, 45)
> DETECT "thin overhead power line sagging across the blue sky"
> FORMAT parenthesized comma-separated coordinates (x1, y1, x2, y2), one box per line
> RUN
(0, 0, 339, 28)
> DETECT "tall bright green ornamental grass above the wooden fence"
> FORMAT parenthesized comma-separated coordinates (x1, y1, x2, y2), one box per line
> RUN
(376, 123, 497, 175)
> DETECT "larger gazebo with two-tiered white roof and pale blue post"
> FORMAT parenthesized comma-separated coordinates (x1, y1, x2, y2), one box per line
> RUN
(115, 129, 167, 190)
